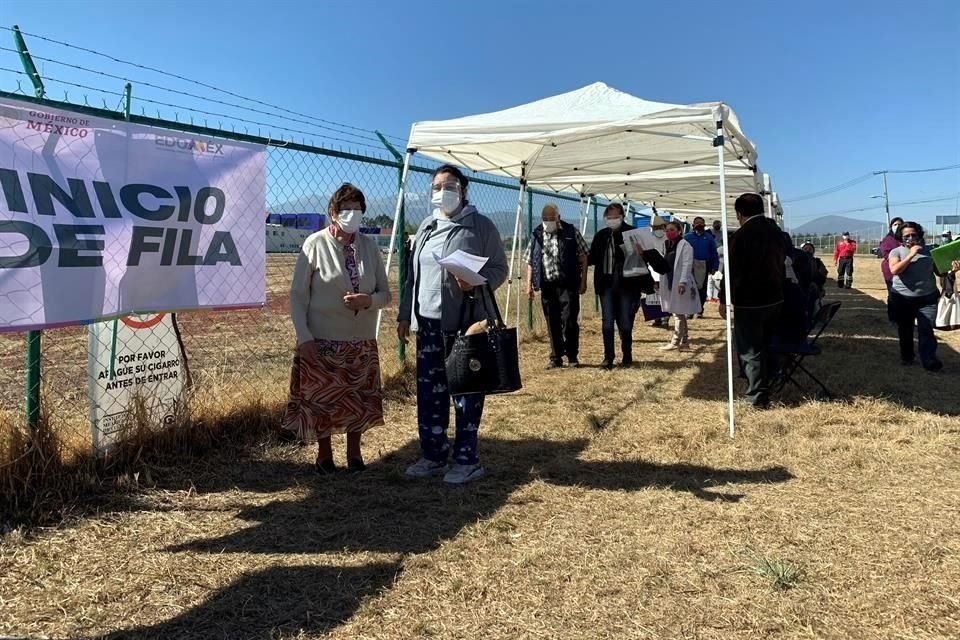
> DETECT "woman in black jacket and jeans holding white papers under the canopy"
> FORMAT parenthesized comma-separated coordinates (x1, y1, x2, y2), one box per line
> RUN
(589, 203, 641, 369)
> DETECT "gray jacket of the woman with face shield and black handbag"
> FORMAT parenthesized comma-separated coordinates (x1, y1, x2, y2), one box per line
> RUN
(397, 204, 508, 333)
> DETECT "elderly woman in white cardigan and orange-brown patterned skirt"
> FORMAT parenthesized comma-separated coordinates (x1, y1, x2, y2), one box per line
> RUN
(282, 184, 390, 474)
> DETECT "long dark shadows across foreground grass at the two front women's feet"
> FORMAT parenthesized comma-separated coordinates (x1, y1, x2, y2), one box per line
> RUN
(107, 439, 793, 640)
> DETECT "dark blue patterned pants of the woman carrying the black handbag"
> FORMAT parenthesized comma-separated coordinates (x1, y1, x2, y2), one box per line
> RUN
(417, 318, 484, 464)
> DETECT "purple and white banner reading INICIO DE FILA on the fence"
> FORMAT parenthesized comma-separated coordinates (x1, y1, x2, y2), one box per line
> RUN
(0, 100, 266, 331)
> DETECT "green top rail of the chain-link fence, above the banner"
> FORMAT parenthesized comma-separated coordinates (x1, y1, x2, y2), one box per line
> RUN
(0, 89, 580, 202)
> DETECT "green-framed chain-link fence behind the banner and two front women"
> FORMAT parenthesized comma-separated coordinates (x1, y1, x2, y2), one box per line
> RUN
(0, 93, 605, 462)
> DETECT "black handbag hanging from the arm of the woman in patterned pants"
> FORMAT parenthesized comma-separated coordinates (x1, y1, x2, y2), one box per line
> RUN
(446, 285, 523, 396)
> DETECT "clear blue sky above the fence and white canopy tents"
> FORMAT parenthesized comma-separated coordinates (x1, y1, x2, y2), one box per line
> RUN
(0, 0, 960, 226)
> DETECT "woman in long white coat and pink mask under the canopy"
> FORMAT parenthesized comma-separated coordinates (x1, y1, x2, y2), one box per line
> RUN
(660, 221, 703, 351)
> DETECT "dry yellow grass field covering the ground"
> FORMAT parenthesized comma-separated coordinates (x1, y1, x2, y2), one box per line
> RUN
(0, 259, 960, 640)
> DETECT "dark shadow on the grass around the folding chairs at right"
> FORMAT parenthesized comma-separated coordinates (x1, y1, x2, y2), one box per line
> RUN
(683, 283, 960, 416)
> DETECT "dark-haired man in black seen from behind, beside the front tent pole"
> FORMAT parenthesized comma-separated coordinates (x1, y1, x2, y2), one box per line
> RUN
(720, 193, 786, 408)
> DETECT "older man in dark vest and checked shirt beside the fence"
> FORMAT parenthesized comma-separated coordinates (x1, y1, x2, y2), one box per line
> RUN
(524, 203, 590, 369)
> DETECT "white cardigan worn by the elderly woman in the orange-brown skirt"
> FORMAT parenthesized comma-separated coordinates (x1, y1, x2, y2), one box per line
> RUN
(290, 229, 390, 344)
